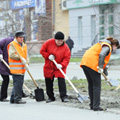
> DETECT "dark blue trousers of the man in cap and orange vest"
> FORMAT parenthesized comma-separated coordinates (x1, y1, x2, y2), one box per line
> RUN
(10, 74, 24, 102)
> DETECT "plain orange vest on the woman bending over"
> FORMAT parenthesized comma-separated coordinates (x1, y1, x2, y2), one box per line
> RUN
(80, 42, 112, 72)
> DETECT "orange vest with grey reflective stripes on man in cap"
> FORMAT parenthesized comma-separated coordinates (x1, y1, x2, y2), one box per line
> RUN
(8, 41, 27, 74)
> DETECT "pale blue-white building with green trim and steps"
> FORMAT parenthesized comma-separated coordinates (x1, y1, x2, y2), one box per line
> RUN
(66, 0, 120, 52)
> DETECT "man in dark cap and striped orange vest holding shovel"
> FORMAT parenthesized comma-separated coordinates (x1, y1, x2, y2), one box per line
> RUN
(8, 31, 28, 104)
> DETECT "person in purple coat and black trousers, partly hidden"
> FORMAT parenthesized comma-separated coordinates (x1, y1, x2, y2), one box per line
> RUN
(0, 37, 28, 102)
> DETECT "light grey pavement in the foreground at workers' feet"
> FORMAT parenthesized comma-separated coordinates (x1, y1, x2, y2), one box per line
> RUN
(0, 98, 120, 120)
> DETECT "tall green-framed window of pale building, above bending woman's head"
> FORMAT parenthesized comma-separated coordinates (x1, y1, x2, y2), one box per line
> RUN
(99, 4, 114, 39)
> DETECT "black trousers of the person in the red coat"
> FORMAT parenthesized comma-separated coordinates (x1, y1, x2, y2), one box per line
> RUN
(45, 77, 67, 100)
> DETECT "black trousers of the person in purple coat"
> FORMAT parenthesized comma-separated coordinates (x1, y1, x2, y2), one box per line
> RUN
(0, 74, 10, 100)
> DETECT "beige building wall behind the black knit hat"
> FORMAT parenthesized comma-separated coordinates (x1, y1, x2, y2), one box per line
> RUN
(52, 0, 69, 39)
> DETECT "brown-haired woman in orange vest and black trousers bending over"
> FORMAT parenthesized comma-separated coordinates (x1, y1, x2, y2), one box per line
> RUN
(80, 37, 119, 111)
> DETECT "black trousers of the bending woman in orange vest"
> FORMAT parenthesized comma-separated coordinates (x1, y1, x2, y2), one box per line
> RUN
(82, 66, 101, 109)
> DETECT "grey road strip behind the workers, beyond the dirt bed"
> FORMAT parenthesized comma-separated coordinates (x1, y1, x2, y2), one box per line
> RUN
(0, 63, 120, 80)
